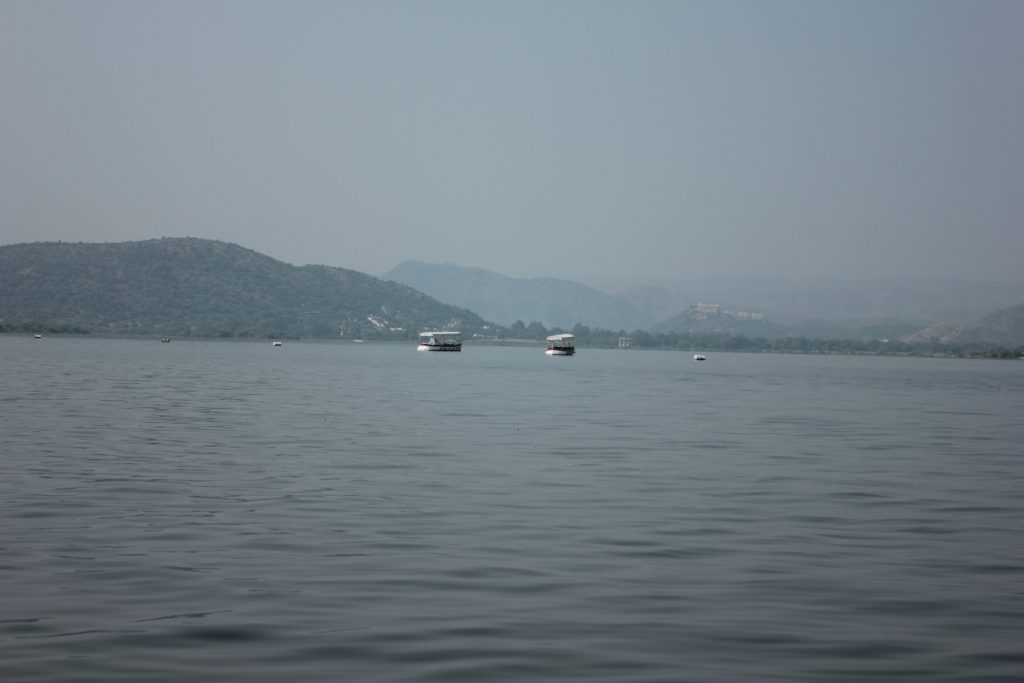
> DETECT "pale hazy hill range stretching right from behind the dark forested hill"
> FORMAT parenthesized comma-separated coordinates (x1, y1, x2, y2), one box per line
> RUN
(382, 261, 1024, 340)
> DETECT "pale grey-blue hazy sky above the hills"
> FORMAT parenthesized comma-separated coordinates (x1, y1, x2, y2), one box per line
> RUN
(0, 0, 1024, 281)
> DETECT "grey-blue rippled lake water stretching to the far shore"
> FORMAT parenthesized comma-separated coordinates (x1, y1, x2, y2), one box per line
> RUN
(0, 337, 1024, 683)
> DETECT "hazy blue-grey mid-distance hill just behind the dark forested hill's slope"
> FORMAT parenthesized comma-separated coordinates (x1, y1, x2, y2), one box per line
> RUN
(381, 261, 654, 330)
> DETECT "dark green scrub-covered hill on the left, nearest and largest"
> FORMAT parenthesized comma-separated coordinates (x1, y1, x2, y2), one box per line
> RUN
(0, 238, 486, 339)
